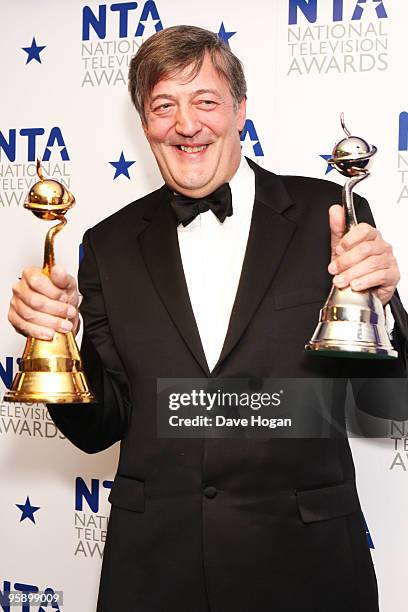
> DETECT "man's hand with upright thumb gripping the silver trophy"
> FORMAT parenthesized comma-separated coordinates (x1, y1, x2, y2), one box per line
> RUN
(328, 204, 401, 306)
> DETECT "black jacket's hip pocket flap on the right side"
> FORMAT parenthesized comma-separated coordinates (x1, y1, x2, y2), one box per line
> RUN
(296, 481, 360, 523)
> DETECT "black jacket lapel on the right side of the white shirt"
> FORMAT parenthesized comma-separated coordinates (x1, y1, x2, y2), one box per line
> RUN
(214, 159, 297, 369)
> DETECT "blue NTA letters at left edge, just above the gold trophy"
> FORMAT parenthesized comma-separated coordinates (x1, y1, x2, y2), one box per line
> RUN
(0, 127, 69, 162)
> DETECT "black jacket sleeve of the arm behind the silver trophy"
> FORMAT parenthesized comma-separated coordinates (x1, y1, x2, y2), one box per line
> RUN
(351, 197, 408, 421)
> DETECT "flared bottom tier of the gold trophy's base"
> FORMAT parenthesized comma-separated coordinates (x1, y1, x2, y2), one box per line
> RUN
(3, 372, 95, 404)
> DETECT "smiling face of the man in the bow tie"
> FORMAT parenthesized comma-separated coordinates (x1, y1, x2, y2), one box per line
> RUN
(143, 56, 245, 198)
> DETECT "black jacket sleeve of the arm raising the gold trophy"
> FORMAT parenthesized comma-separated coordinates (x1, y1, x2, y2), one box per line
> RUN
(47, 230, 131, 453)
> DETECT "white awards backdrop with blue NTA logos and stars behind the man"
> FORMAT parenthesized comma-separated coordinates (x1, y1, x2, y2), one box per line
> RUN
(0, 0, 408, 612)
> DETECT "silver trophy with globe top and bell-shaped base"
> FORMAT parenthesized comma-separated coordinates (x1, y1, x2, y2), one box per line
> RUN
(305, 113, 398, 359)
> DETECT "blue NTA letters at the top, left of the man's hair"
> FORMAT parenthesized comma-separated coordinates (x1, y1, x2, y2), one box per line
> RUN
(82, 0, 163, 40)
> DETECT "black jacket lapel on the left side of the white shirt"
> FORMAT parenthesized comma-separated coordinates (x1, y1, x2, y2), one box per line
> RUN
(139, 187, 209, 376)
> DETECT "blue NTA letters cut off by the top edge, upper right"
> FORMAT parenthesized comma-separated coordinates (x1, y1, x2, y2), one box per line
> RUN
(289, 0, 388, 25)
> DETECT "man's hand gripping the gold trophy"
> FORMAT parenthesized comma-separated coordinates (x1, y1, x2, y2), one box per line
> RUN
(8, 266, 79, 340)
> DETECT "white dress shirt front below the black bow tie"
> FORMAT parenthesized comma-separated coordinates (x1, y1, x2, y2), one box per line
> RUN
(177, 156, 255, 371)
